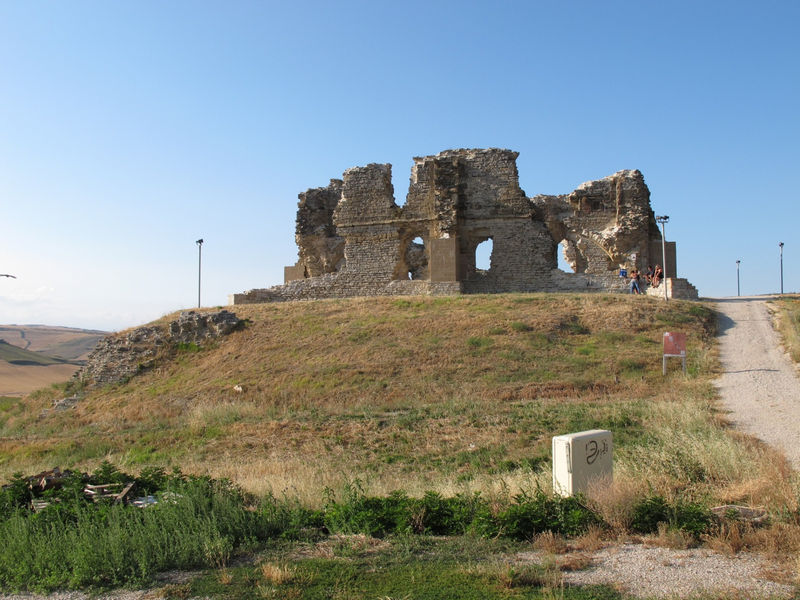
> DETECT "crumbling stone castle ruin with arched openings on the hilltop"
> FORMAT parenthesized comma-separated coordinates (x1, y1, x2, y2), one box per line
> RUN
(232, 148, 697, 304)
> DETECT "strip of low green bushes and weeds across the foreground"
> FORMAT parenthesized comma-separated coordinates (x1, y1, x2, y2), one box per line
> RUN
(0, 463, 712, 591)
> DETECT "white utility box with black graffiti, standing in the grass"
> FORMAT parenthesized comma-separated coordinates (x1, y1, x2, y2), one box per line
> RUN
(553, 429, 613, 496)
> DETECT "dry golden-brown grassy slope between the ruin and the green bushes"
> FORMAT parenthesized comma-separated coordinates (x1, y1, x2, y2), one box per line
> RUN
(0, 295, 794, 520)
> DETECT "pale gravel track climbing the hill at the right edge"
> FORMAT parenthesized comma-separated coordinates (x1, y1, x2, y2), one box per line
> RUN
(713, 296, 800, 469)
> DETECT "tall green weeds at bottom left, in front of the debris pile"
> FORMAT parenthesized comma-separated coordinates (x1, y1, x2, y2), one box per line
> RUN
(0, 465, 268, 590)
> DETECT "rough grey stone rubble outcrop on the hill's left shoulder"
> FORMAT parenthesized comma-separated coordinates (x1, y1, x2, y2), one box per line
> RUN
(73, 310, 242, 387)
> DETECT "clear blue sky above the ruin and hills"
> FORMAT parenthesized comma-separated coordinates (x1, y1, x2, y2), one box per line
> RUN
(0, 0, 800, 329)
